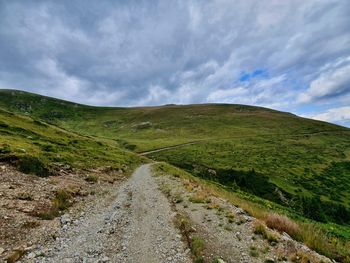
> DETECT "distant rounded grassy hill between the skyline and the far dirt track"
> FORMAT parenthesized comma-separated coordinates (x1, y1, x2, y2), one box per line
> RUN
(0, 90, 348, 151)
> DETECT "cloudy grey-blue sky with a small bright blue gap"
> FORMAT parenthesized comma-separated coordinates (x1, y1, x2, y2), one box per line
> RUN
(0, 0, 350, 126)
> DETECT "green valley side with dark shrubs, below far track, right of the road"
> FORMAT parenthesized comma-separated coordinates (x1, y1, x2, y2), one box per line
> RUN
(149, 134, 350, 224)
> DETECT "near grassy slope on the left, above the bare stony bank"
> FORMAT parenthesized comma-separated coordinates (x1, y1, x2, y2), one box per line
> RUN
(0, 104, 141, 173)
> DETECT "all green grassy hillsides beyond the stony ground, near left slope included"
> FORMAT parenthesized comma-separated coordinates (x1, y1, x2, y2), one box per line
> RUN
(0, 90, 350, 260)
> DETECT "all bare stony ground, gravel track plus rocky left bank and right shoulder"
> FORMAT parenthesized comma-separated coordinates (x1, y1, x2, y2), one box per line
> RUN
(0, 164, 329, 263)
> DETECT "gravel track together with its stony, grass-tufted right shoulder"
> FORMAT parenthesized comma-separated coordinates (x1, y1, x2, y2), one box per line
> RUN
(21, 164, 331, 263)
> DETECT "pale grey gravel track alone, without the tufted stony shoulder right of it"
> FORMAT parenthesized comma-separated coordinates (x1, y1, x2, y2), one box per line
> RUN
(22, 164, 191, 263)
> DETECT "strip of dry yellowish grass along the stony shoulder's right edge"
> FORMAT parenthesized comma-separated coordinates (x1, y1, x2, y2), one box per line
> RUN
(154, 166, 350, 263)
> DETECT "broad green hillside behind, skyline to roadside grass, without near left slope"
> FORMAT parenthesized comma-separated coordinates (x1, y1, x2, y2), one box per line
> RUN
(0, 90, 350, 228)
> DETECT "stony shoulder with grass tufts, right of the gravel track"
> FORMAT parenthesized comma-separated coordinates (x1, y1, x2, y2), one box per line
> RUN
(152, 169, 331, 263)
